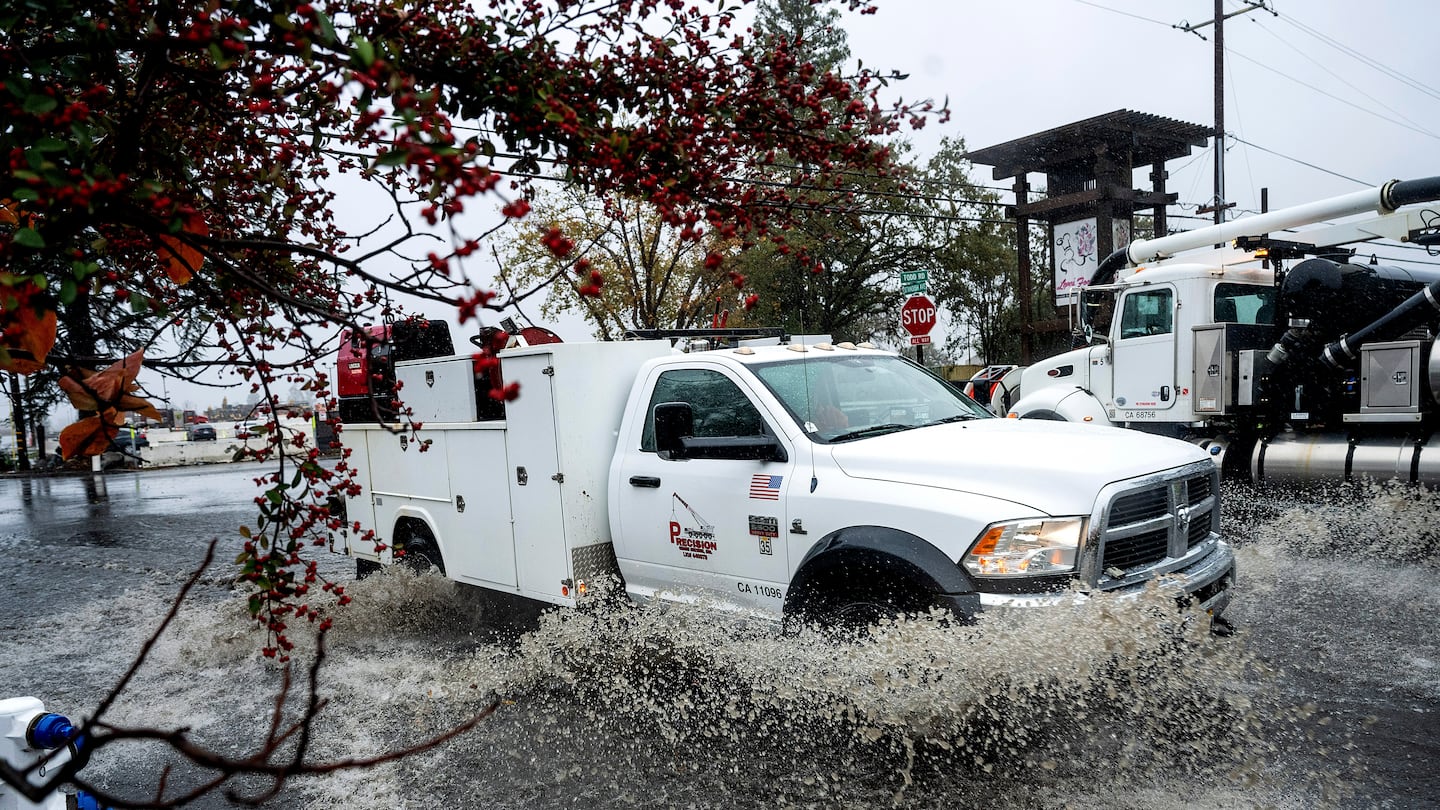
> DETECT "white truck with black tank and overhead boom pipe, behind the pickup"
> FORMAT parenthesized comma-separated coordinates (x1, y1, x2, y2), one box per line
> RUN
(1005, 177, 1440, 484)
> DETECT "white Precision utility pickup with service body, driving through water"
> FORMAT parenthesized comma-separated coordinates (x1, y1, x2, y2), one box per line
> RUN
(333, 330, 1234, 624)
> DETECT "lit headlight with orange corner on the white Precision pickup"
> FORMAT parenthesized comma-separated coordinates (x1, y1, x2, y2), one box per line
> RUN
(960, 517, 1084, 577)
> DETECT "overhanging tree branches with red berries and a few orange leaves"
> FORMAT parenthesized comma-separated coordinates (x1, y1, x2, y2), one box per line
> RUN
(0, 0, 930, 801)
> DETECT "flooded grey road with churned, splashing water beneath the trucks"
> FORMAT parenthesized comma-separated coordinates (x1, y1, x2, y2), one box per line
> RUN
(0, 466, 1440, 809)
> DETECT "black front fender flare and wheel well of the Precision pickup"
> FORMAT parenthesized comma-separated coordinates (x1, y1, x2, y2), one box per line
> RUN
(785, 526, 981, 617)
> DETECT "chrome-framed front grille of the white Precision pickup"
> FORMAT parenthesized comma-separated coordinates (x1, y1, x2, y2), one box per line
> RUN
(1081, 461, 1220, 589)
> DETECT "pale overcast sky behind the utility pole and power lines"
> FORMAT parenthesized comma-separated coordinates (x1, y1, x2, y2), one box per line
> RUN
(109, 0, 1440, 408)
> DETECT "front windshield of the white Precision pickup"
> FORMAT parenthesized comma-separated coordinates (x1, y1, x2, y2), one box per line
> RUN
(752, 353, 992, 442)
